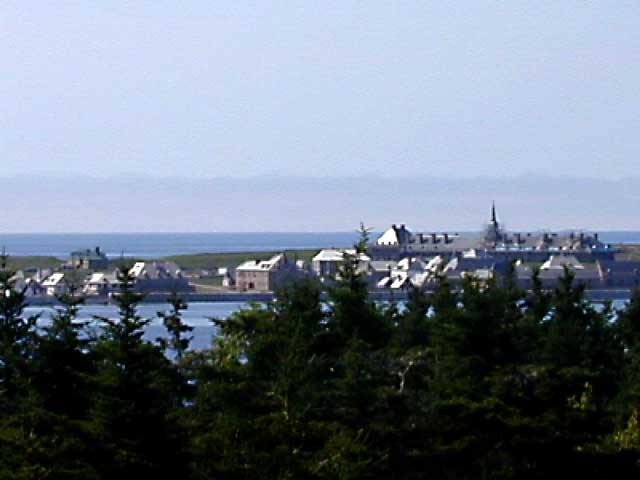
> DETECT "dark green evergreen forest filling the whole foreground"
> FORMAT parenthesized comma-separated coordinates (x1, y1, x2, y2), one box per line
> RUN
(0, 249, 640, 479)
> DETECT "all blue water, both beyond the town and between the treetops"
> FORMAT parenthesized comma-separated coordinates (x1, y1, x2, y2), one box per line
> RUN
(10, 232, 640, 349)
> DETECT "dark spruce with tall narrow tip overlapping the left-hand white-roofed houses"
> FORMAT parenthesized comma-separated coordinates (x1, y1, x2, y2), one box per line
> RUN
(90, 264, 185, 478)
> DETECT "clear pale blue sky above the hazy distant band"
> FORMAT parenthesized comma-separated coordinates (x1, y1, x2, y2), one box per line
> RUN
(0, 0, 640, 178)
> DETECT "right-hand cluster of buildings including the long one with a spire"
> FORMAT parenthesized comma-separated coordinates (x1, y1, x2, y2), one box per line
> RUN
(235, 205, 640, 291)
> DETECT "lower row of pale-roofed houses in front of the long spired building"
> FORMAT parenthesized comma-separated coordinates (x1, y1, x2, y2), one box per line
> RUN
(236, 249, 640, 291)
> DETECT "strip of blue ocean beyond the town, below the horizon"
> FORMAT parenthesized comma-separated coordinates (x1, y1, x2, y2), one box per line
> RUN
(0, 231, 640, 258)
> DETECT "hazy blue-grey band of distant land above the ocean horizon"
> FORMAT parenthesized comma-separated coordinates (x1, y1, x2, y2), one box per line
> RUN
(0, 172, 640, 233)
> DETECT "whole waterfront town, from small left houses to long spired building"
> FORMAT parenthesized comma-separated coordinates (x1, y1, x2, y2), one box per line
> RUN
(16, 205, 640, 297)
